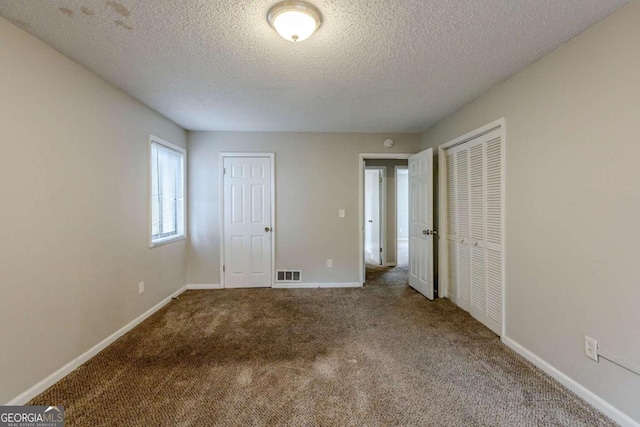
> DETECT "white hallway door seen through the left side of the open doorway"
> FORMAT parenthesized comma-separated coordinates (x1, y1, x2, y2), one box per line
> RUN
(364, 168, 382, 265)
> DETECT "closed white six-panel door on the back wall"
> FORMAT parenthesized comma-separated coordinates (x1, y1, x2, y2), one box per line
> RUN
(222, 157, 273, 288)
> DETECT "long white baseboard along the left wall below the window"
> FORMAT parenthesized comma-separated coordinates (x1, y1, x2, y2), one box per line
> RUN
(5, 286, 186, 406)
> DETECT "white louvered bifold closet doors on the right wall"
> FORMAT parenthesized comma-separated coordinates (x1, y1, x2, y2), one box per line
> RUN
(444, 129, 504, 334)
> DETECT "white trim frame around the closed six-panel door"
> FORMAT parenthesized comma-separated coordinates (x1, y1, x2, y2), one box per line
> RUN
(218, 152, 277, 288)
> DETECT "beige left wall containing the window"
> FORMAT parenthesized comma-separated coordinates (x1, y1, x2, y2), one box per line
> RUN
(0, 18, 186, 403)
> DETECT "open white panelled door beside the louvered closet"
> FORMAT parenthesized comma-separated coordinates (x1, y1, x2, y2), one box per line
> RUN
(409, 148, 436, 300)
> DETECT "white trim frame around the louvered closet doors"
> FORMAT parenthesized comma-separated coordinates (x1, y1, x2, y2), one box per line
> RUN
(438, 117, 507, 337)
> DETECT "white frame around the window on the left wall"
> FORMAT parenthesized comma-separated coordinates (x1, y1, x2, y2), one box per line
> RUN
(147, 135, 187, 248)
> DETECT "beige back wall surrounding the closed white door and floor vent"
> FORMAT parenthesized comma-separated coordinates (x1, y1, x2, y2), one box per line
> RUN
(188, 132, 421, 284)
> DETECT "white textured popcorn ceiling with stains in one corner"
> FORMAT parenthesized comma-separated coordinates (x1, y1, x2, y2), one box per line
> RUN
(0, 0, 627, 132)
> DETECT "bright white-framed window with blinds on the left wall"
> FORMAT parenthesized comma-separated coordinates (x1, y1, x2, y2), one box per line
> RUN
(149, 136, 186, 247)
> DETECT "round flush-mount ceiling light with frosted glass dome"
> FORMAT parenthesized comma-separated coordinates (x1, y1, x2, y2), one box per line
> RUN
(267, 1, 322, 42)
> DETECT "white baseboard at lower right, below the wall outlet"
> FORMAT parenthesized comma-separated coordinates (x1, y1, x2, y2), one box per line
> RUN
(502, 336, 640, 427)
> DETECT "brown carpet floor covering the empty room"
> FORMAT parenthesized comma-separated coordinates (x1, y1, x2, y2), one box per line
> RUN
(30, 267, 614, 426)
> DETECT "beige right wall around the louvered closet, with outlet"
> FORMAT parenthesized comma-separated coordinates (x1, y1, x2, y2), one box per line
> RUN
(423, 2, 640, 421)
